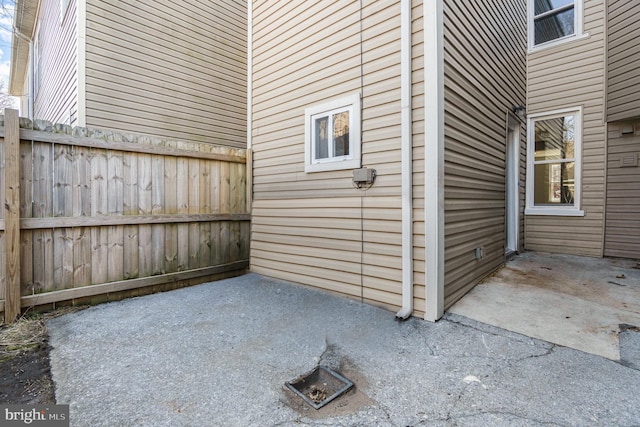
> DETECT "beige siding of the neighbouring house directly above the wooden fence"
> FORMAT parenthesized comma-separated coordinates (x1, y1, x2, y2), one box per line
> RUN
(86, 0, 247, 147)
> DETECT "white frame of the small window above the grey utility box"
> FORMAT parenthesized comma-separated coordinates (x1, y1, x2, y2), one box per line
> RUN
(304, 93, 361, 173)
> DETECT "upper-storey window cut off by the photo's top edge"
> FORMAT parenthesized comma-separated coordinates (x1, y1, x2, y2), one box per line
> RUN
(528, 0, 582, 49)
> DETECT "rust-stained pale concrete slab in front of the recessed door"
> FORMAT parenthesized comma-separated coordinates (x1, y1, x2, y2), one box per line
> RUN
(449, 252, 640, 363)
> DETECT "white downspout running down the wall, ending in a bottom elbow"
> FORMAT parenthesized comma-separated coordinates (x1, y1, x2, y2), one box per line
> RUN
(396, 0, 413, 320)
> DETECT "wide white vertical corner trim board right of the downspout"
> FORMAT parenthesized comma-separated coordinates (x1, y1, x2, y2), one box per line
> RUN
(422, 0, 444, 321)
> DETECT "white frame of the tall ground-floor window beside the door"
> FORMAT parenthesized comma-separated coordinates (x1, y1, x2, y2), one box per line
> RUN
(524, 107, 584, 216)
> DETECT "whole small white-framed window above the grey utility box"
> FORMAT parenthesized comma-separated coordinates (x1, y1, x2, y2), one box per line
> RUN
(304, 94, 360, 172)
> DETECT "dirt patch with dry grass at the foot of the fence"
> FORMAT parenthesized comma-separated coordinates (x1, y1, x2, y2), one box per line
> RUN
(0, 307, 81, 405)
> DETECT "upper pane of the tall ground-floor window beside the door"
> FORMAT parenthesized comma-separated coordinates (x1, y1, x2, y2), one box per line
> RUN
(534, 116, 575, 161)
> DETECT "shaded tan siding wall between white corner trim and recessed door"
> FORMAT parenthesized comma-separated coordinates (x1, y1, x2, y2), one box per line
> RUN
(444, 0, 526, 308)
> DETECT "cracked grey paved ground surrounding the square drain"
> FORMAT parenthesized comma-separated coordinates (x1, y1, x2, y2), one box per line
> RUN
(48, 274, 640, 426)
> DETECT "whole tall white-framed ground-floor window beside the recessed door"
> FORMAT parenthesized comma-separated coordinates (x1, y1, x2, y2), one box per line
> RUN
(525, 108, 584, 216)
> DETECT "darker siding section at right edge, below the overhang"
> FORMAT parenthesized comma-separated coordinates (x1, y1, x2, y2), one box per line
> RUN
(604, 122, 640, 259)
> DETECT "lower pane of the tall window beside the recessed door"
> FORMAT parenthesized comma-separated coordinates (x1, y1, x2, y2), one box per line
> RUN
(533, 162, 575, 206)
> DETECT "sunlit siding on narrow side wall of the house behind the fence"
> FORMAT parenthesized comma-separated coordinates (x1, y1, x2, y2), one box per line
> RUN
(33, 0, 78, 125)
